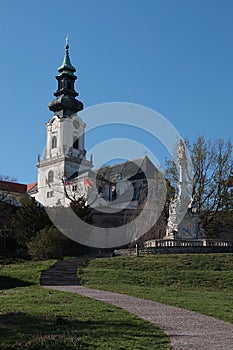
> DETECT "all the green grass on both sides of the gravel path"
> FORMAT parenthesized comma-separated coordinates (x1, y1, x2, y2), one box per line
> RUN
(0, 254, 233, 350)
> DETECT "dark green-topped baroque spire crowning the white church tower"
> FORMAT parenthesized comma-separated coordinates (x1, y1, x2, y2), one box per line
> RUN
(48, 37, 83, 118)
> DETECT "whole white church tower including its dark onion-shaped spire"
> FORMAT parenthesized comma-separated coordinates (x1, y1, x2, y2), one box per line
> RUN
(35, 39, 93, 206)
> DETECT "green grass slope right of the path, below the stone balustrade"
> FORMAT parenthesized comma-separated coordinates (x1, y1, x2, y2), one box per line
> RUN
(79, 254, 233, 322)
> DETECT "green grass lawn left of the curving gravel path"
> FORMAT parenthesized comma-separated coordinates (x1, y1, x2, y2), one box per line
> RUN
(0, 261, 170, 350)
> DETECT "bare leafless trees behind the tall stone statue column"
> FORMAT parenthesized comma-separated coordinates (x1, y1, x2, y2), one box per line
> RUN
(165, 136, 233, 238)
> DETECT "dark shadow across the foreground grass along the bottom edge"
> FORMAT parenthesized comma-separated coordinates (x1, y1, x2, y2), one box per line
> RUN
(0, 312, 168, 350)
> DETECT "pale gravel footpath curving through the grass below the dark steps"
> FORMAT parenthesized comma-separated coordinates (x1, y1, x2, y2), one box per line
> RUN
(45, 286, 233, 350)
